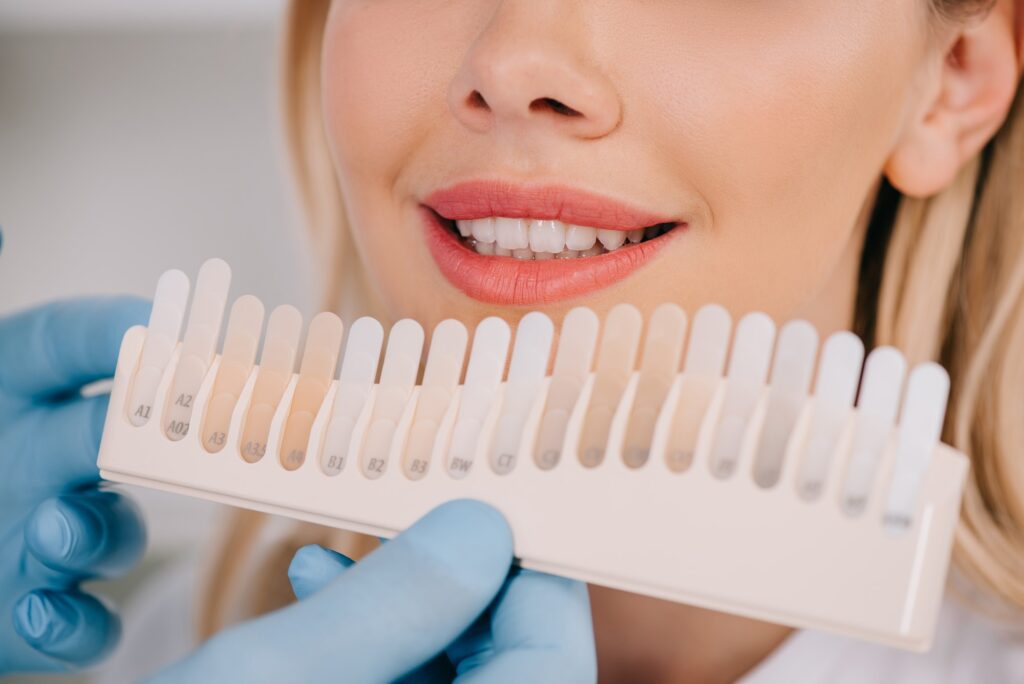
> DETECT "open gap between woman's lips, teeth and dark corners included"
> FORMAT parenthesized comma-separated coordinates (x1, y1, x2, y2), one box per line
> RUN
(437, 214, 679, 261)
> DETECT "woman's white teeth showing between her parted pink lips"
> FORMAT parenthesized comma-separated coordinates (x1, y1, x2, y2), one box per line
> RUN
(455, 217, 644, 258)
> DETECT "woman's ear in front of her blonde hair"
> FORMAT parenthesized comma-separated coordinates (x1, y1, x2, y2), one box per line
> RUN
(885, 0, 1024, 198)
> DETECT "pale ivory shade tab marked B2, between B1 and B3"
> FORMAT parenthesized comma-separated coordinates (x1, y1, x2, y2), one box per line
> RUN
(361, 318, 423, 479)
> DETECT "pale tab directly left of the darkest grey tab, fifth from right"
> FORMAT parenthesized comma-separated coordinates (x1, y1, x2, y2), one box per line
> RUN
(711, 312, 775, 477)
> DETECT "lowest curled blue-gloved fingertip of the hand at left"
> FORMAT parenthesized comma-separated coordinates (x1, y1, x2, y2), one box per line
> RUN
(13, 589, 121, 670)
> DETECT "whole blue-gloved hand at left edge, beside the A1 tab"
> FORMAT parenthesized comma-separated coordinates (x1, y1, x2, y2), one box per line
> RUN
(0, 298, 148, 675)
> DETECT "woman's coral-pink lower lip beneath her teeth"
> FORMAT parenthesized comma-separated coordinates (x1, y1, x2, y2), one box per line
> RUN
(420, 205, 682, 306)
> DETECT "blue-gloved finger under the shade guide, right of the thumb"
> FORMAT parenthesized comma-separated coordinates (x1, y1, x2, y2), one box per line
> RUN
(447, 569, 597, 684)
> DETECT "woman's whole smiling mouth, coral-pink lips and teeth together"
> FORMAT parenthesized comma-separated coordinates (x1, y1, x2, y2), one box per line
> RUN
(419, 179, 689, 305)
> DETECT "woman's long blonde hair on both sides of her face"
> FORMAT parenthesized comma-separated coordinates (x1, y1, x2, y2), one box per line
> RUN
(199, 0, 1024, 638)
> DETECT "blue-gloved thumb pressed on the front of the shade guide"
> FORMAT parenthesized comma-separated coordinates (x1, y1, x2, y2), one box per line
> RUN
(154, 500, 512, 683)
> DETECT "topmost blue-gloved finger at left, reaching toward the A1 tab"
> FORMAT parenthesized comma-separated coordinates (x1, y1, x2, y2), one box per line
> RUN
(0, 297, 150, 399)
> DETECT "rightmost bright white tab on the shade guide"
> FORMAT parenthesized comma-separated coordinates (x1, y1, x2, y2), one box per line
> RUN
(884, 362, 949, 531)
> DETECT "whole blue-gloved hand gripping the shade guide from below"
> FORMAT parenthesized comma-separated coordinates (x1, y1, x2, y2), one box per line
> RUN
(150, 500, 597, 684)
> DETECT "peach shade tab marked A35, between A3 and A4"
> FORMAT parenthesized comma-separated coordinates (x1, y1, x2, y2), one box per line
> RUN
(239, 305, 302, 463)
